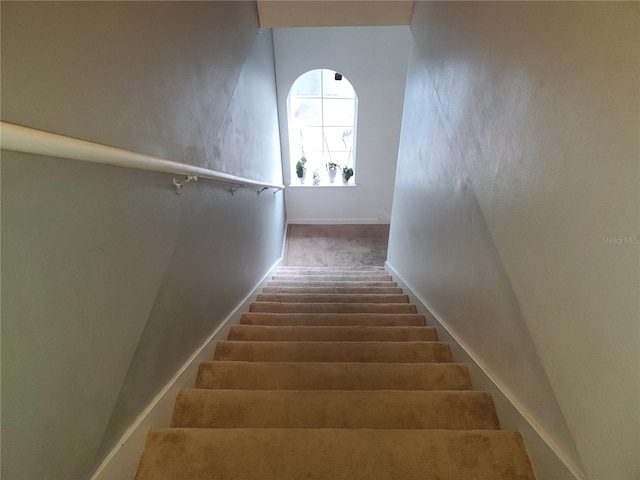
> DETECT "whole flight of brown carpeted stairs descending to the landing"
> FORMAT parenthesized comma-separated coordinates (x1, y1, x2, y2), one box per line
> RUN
(136, 267, 534, 480)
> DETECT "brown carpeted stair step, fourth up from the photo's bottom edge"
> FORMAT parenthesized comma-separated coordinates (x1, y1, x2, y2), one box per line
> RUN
(214, 342, 452, 363)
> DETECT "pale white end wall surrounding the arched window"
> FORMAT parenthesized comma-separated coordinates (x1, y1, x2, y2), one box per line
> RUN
(273, 27, 410, 223)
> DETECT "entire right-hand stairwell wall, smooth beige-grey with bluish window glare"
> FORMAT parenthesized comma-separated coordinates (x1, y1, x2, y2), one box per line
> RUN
(389, 2, 640, 480)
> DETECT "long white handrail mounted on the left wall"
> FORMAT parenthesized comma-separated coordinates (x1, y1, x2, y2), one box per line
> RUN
(0, 122, 284, 191)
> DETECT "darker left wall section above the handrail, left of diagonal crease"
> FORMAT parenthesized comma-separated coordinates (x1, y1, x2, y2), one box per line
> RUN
(2, 1, 272, 179)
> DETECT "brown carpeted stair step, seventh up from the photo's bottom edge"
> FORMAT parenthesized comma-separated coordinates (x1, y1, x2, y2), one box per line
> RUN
(249, 302, 417, 313)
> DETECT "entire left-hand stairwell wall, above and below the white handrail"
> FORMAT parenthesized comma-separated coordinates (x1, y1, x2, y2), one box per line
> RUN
(1, 2, 284, 479)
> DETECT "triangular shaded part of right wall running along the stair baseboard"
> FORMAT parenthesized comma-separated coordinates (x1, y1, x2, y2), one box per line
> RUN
(388, 15, 580, 480)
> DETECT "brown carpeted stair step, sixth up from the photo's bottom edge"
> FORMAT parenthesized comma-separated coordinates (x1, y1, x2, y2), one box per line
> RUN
(240, 312, 427, 327)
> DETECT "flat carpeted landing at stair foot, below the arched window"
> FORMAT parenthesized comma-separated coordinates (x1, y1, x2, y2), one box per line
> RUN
(284, 225, 389, 267)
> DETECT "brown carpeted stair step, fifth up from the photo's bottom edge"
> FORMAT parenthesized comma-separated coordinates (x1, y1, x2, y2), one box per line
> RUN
(229, 325, 438, 342)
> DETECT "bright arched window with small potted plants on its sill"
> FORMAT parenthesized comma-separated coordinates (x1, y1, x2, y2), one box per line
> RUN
(287, 69, 358, 185)
